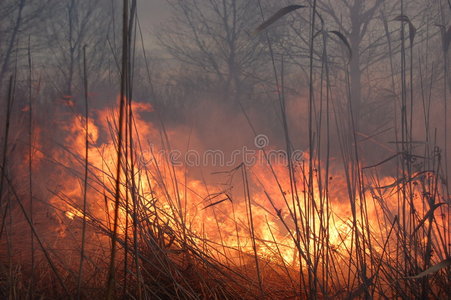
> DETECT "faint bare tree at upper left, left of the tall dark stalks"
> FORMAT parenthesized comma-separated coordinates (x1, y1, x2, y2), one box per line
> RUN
(47, 0, 115, 97)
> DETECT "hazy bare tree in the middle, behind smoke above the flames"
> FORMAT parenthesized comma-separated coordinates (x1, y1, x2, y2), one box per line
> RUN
(159, 0, 266, 103)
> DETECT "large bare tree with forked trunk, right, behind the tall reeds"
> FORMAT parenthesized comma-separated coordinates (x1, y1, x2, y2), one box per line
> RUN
(282, 0, 400, 126)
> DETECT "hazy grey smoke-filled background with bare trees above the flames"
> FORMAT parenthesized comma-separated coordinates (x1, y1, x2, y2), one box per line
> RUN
(0, 1, 449, 171)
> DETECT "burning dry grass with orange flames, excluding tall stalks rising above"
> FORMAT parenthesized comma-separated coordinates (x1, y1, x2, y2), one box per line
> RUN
(2, 98, 449, 299)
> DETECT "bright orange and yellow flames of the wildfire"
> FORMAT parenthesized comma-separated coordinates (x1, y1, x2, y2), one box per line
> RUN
(28, 98, 448, 284)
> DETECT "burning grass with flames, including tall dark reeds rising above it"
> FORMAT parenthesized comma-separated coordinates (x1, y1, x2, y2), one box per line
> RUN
(0, 0, 451, 299)
